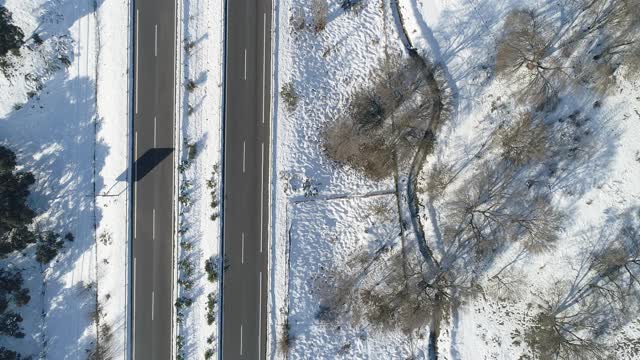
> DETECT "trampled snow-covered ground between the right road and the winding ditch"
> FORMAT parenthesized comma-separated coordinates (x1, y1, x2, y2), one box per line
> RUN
(269, 1, 404, 359)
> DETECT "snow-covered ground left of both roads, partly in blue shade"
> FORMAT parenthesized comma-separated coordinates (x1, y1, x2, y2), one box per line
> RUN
(0, 0, 129, 359)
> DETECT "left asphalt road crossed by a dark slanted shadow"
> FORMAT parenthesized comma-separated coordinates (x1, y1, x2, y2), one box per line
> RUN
(130, 0, 176, 360)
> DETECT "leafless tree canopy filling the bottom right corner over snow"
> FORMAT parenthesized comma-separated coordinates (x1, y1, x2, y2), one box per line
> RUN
(525, 209, 640, 359)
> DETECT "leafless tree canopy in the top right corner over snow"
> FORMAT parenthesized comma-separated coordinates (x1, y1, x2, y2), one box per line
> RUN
(496, 0, 640, 105)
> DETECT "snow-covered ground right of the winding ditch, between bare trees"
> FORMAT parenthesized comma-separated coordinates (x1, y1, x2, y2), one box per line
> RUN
(400, 0, 640, 359)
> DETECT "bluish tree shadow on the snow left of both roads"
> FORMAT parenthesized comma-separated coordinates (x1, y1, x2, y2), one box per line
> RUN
(0, 0, 109, 359)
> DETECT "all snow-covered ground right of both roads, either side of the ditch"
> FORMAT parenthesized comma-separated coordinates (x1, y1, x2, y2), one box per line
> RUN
(269, 0, 640, 359)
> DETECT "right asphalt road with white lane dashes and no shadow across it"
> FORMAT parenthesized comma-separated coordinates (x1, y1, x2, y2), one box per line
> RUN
(221, 0, 272, 360)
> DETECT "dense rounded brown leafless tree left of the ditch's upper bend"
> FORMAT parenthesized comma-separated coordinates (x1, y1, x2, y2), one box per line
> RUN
(324, 59, 440, 180)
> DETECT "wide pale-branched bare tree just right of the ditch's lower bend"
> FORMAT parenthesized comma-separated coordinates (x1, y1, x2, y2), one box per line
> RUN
(444, 163, 563, 259)
